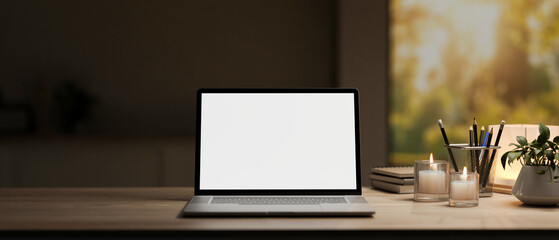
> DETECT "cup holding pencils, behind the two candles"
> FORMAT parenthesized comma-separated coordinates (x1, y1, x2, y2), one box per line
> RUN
(445, 144, 501, 197)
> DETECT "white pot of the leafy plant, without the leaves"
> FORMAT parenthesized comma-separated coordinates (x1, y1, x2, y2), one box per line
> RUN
(512, 166, 559, 206)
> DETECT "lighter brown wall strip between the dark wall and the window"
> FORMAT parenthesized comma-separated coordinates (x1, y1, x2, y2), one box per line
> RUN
(338, 0, 389, 182)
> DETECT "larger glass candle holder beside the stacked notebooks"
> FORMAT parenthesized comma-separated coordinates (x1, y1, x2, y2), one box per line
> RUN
(413, 160, 448, 202)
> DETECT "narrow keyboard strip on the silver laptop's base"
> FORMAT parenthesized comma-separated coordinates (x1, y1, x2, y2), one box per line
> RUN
(211, 197, 347, 205)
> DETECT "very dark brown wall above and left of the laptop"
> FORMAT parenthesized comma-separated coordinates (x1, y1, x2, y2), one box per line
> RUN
(0, 0, 336, 135)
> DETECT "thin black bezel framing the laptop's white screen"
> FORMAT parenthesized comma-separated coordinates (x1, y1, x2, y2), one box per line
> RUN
(194, 88, 361, 195)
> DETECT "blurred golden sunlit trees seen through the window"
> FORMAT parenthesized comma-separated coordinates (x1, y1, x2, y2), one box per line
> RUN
(389, 0, 559, 165)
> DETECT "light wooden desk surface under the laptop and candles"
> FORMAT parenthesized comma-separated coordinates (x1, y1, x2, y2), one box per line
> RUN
(0, 187, 559, 231)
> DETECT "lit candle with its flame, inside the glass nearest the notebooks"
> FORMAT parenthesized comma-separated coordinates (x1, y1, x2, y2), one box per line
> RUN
(418, 153, 446, 193)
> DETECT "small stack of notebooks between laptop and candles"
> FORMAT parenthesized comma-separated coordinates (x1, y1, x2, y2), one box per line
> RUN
(370, 167, 414, 193)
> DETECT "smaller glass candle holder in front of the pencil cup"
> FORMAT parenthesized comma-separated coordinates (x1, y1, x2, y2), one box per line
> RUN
(448, 171, 479, 207)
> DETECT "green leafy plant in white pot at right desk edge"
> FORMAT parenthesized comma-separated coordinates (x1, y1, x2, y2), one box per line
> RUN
(501, 123, 559, 205)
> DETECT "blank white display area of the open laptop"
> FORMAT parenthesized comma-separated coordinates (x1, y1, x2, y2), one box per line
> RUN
(200, 93, 357, 190)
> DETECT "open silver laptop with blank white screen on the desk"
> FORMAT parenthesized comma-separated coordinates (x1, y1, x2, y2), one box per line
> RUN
(180, 89, 375, 217)
